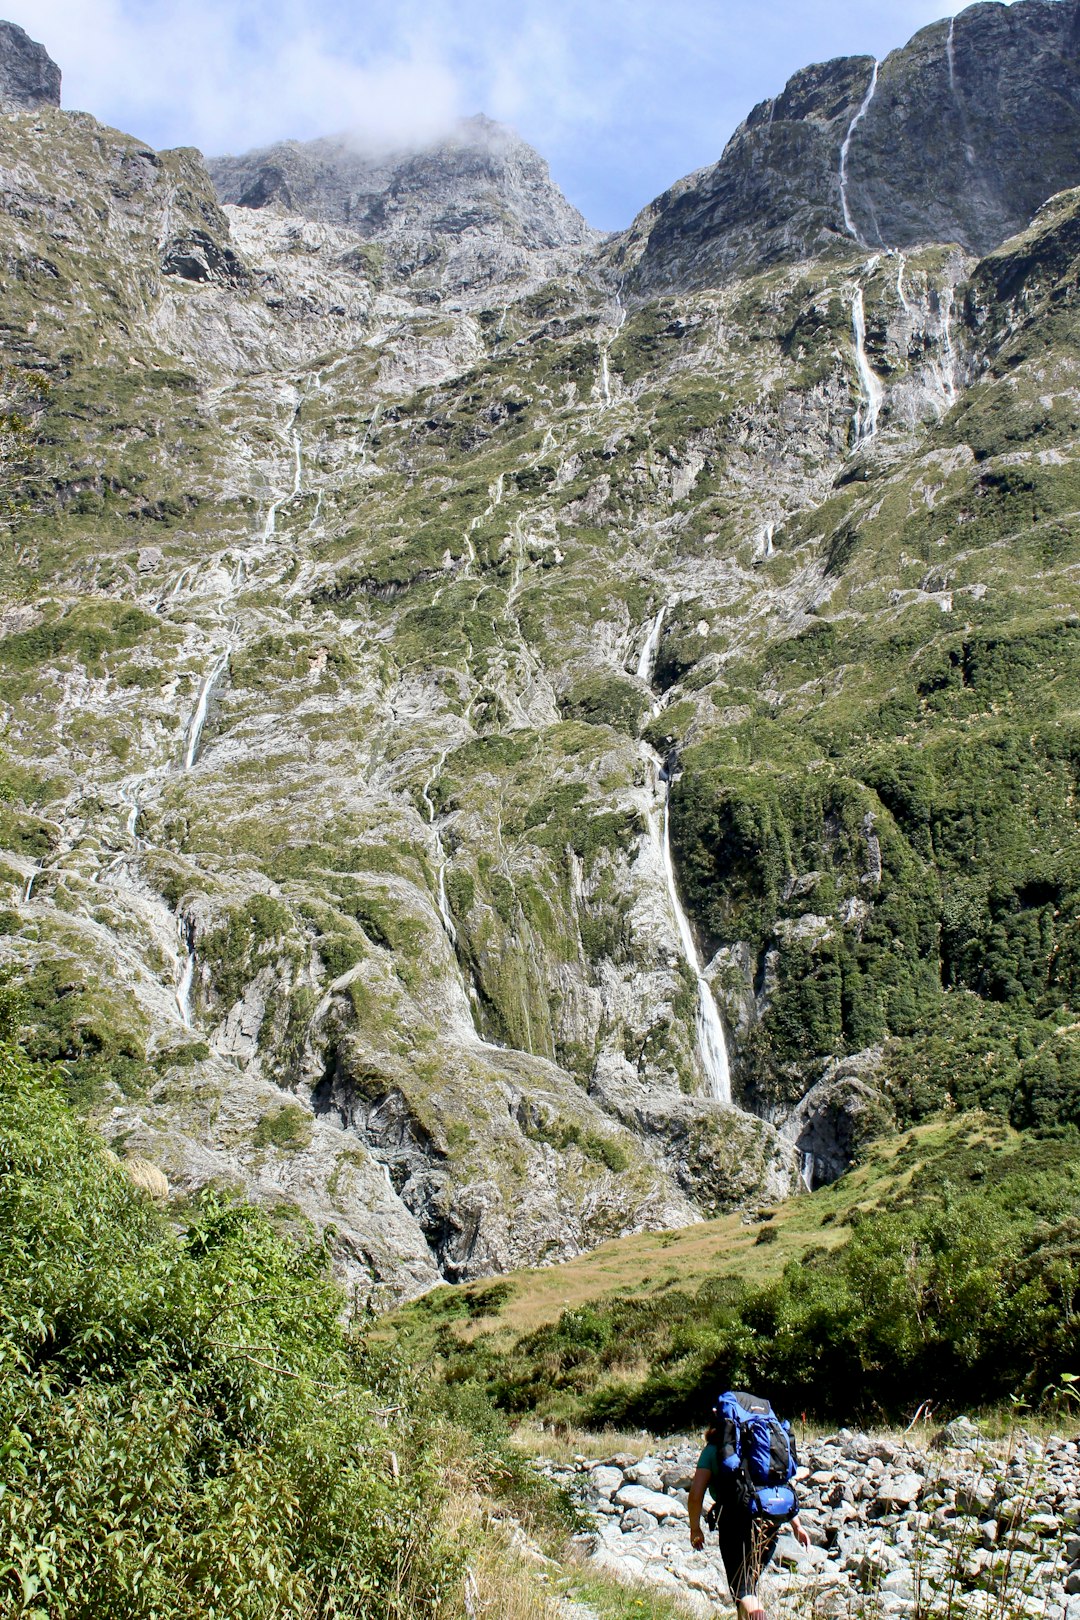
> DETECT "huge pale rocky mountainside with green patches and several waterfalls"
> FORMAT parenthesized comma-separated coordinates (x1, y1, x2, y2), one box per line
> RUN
(0, 12, 1080, 1293)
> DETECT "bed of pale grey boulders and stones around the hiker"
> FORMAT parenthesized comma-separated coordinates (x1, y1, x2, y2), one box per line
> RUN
(539, 1419, 1080, 1620)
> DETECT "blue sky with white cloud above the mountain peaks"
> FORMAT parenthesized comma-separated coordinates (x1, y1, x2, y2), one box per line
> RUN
(12, 0, 1016, 230)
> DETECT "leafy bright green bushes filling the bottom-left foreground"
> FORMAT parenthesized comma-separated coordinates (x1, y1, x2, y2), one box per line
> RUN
(0, 1047, 463, 1620)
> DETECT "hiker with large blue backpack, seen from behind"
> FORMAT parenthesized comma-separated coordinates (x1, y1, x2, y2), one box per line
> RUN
(687, 1390, 810, 1620)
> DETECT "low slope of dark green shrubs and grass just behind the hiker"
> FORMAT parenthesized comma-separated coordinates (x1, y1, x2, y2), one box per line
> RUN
(411, 1119, 1080, 1432)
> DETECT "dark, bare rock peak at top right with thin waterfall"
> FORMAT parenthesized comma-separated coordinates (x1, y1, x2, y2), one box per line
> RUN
(612, 0, 1080, 295)
